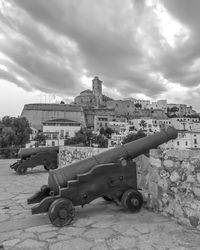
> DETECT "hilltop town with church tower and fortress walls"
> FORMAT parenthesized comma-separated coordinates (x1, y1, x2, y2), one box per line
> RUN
(21, 76, 200, 148)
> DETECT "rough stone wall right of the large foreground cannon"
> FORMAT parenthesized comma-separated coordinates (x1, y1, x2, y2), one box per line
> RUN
(136, 149, 200, 229)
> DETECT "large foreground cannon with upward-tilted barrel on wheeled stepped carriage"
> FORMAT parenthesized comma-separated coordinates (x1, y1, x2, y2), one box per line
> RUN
(28, 127, 177, 226)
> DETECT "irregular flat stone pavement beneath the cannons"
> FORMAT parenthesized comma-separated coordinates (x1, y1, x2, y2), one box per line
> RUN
(0, 160, 200, 250)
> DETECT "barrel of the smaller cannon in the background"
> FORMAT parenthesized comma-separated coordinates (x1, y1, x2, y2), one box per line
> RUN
(18, 146, 59, 159)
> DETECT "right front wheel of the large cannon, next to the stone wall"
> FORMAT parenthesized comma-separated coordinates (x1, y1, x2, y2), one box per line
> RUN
(121, 189, 143, 212)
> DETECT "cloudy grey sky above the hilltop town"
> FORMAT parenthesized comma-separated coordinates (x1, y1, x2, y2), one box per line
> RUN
(0, 0, 200, 118)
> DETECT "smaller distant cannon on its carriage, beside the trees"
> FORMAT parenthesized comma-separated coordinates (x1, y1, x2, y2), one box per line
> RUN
(10, 146, 59, 174)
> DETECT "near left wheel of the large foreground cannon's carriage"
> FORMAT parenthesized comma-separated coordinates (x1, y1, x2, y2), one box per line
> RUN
(49, 198, 75, 227)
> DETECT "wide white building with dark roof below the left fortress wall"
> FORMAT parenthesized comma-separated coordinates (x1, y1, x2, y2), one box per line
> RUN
(43, 119, 81, 146)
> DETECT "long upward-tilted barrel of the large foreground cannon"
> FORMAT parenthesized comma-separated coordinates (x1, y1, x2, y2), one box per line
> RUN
(48, 127, 178, 193)
